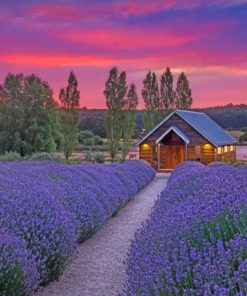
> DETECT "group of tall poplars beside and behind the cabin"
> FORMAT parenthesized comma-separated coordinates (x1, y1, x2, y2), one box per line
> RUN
(104, 67, 193, 161)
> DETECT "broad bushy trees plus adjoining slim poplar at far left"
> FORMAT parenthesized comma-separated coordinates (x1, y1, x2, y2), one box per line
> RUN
(0, 72, 80, 159)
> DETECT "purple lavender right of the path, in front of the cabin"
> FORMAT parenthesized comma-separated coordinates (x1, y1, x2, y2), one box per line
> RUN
(121, 162, 247, 296)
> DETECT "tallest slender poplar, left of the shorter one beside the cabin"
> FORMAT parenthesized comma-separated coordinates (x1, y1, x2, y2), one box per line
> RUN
(104, 67, 127, 161)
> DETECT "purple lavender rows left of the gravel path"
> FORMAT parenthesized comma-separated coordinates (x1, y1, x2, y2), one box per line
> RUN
(0, 161, 155, 296)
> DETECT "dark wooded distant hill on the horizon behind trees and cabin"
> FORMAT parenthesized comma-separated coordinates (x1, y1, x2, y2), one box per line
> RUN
(80, 104, 247, 137)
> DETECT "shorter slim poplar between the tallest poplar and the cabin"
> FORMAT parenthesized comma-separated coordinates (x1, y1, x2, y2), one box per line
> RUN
(122, 84, 138, 161)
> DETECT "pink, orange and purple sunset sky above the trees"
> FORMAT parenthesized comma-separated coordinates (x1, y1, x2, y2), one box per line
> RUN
(0, 0, 247, 108)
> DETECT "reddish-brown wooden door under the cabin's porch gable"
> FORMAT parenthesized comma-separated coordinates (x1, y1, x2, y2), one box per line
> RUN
(164, 145, 185, 169)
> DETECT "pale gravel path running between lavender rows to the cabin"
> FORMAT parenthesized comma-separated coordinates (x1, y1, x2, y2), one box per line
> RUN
(35, 174, 168, 296)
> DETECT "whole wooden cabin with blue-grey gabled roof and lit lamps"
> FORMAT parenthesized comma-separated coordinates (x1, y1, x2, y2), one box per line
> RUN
(138, 110, 237, 171)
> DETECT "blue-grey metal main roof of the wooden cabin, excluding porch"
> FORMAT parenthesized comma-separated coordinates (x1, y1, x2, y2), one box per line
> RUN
(138, 110, 237, 147)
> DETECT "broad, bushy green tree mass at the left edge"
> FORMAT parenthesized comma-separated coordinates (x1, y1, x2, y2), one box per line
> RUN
(0, 73, 61, 156)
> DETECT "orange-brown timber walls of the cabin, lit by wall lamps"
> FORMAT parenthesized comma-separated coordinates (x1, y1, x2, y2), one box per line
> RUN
(139, 114, 236, 170)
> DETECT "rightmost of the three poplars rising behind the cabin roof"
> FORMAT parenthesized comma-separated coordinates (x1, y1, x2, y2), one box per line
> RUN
(175, 72, 193, 110)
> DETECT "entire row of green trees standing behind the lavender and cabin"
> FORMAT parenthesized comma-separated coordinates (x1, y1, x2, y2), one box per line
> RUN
(0, 67, 192, 161)
